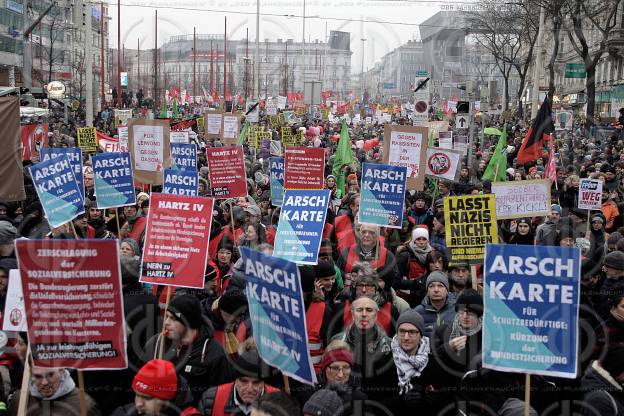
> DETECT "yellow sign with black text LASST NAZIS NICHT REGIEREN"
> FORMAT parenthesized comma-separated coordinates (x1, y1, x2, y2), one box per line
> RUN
(444, 194, 498, 266)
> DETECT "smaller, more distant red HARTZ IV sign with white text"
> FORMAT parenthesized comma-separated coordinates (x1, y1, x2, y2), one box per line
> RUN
(206, 146, 247, 199)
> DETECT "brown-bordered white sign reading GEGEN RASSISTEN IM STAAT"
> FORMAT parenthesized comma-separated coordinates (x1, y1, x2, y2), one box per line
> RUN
(384, 123, 429, 191)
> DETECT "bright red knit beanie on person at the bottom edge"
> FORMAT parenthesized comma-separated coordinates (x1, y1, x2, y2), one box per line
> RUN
(132, 360, 178, 400)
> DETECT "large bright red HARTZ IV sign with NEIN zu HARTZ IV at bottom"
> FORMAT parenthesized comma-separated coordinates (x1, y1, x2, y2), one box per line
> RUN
(139, 193, 214, 289)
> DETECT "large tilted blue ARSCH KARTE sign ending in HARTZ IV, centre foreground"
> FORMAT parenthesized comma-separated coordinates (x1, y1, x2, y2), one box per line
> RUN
(240, 247, 316, 385)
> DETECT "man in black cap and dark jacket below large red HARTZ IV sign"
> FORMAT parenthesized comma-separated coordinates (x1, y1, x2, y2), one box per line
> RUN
(144, 295, 232, 400)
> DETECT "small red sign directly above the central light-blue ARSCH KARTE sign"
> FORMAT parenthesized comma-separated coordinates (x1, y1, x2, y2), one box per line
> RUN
(284, 147, 325, 189)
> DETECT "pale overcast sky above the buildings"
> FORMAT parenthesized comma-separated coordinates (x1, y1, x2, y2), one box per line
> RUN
(103, 0, 470, 72)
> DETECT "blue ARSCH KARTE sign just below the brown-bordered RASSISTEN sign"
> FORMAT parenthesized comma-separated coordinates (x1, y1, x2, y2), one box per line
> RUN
(359, 163, 407, 228)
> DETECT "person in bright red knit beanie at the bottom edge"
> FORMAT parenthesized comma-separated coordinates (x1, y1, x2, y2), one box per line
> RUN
(111, 360, 200, 416)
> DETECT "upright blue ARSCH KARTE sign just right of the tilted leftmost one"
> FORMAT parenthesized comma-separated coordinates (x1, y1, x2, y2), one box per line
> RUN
(91, 152, 136, 209)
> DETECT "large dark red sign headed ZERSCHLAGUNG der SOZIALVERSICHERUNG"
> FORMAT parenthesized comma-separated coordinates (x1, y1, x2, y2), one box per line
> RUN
(15, 240, 128, 370)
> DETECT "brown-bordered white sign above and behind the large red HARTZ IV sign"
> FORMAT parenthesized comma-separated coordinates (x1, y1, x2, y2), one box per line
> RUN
(128, 119, 170, 185)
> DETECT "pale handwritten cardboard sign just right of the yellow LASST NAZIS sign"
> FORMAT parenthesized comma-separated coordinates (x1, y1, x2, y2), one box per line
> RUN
(492, 179, 551, 220)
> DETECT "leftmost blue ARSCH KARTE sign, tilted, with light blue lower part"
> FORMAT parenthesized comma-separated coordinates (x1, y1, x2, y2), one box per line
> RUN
(30, 155, 84, 227)
